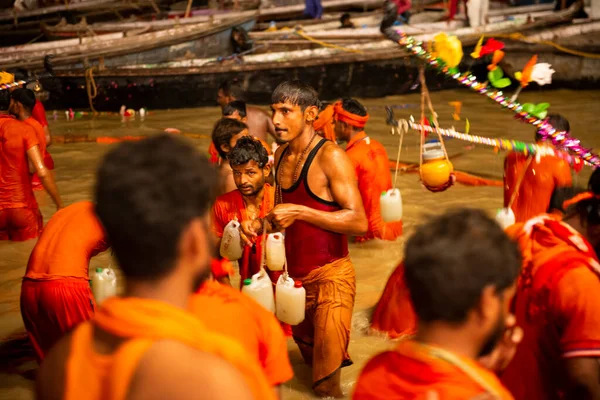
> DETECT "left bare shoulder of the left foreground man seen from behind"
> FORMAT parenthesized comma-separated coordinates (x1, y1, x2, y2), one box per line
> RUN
(35, 334, 72, 400)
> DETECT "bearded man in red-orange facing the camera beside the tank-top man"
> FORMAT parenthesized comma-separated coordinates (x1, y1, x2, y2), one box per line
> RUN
(213, 137, 275, 283)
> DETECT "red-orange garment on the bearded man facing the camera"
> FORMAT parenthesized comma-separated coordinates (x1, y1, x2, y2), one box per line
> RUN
(213, 183, 275, 281)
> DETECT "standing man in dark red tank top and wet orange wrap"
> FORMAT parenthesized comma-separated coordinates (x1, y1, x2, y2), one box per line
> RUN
(242, 81, 368, 397)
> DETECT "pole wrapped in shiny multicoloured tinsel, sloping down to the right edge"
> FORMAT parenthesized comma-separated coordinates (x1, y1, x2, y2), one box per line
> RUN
(390, 32, 600, 167)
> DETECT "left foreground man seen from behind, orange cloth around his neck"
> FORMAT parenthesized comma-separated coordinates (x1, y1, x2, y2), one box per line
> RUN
(37, 135, 275, 400)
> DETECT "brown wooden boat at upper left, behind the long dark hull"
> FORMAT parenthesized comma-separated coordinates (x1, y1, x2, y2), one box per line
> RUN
(0, 18, 254, 70)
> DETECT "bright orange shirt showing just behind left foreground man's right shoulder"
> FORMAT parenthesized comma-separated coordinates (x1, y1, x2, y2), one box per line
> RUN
(190, 281, 294, 386)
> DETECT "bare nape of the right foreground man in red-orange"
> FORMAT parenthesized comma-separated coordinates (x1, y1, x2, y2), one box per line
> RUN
(415, 322, 479, 359)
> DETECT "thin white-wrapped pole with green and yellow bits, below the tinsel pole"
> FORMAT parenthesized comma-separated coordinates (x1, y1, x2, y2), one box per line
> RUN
(407, 116, 590, 170)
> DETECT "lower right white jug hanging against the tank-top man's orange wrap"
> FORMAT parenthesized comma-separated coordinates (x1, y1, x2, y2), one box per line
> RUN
(275, 274, 306, 325)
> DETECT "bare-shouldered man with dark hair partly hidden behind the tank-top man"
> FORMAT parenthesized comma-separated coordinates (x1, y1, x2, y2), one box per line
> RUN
(217, 79, 277, 141)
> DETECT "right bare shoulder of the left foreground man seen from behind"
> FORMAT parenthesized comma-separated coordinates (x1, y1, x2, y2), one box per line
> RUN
(127, 340, 252, 400)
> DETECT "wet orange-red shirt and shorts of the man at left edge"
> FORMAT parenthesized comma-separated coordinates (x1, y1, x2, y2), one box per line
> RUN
(0, 114, 42, 241)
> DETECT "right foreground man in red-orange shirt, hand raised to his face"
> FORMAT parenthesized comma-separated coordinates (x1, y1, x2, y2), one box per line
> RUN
(353, 209, 520, 400)
